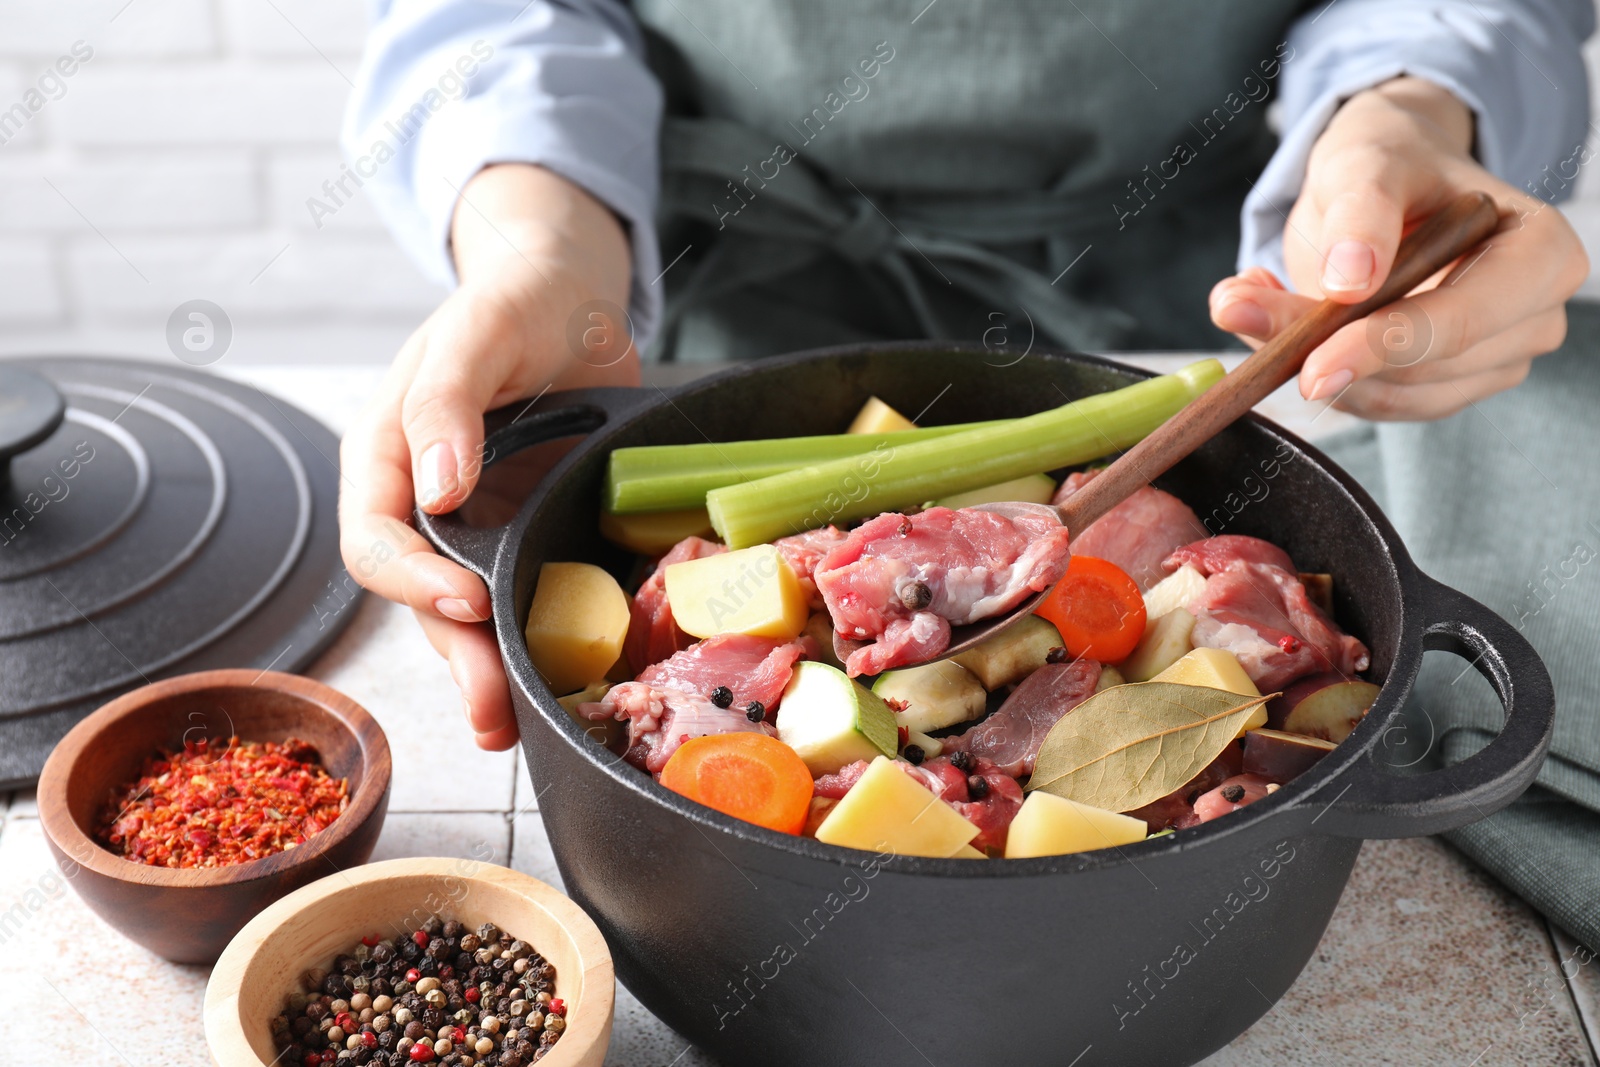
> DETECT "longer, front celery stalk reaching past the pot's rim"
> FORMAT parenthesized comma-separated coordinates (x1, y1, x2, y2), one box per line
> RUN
(706, 360, 1224, 549)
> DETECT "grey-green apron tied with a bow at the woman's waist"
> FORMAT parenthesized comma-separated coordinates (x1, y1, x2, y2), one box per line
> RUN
(635, 0, 1307, 360)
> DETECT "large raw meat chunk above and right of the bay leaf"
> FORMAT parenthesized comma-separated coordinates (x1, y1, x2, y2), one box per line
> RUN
(1166, 534, 1371, 693)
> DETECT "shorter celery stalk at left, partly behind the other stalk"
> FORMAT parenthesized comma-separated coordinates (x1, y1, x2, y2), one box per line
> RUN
(605, 419, 1011, 515)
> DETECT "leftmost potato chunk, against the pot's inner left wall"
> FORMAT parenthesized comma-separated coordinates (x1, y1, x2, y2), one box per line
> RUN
(523, 563, 629, 696)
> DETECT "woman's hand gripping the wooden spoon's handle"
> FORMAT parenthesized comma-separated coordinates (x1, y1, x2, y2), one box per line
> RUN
(1211, 77, 1589, 419)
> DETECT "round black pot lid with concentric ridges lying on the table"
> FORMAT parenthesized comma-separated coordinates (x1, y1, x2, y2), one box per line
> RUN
(0, 357, 358, 789)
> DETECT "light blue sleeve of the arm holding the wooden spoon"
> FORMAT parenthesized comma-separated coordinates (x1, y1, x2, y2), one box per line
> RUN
(1238, 0, 1595, 283)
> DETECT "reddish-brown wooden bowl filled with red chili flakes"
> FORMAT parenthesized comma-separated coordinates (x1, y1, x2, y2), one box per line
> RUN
(38, 670, 390, 963)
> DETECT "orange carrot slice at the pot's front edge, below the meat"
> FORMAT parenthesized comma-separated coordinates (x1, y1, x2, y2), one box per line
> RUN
(661, 733, 813, 833)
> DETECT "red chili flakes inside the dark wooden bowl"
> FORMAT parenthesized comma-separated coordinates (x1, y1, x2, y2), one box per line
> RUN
(96, 737, 349, 867)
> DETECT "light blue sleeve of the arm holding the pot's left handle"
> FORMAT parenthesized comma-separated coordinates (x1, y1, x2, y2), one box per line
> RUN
(342, 0, 662, 350)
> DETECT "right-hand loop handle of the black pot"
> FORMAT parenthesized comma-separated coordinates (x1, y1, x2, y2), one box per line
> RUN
(1309, 574, 1555, 838)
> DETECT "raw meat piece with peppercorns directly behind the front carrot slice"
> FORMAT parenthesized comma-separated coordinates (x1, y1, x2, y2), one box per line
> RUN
(578, 633, 805, 774)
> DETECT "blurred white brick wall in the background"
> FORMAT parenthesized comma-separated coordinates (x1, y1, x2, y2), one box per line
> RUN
(0, 0, 1600, 363)
